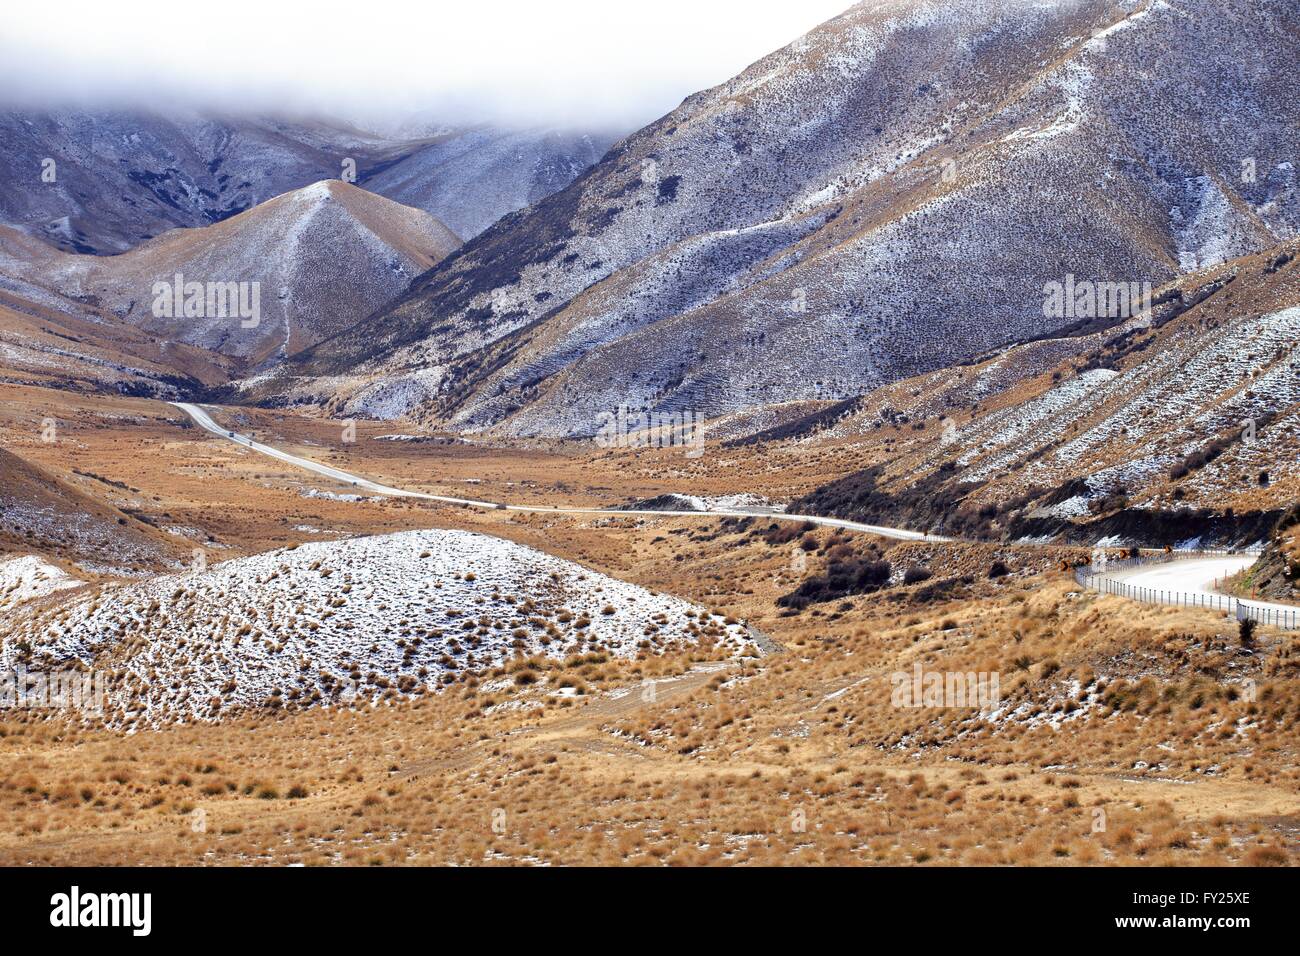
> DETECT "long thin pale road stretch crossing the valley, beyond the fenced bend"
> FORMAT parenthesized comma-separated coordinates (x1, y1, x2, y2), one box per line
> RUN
(170, 402, 952, 541)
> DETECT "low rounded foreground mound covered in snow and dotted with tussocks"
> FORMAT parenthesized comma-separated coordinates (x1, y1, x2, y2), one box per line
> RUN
(0, 531, 746, 724)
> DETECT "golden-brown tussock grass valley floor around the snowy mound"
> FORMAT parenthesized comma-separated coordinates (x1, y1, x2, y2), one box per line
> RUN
(0, 389, 1300, 865)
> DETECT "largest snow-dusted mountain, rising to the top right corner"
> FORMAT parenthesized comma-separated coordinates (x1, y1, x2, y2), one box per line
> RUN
(276, 0, 1300, 434)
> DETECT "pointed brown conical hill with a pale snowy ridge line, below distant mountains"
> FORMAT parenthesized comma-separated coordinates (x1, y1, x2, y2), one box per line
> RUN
(3, 179, 459, 365)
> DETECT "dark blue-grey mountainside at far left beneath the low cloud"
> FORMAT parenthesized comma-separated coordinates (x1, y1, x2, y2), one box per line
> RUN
(0, 111, 400, 254)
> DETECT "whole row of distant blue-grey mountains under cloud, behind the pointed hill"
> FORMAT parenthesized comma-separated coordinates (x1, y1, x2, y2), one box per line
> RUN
(0, 111, 610, 255)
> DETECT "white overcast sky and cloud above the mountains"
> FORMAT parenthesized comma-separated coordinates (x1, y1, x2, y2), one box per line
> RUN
(0, 0, 850, 129)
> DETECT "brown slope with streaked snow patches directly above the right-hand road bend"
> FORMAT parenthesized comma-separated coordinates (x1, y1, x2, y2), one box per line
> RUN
(780, 239, 1300, 545)
